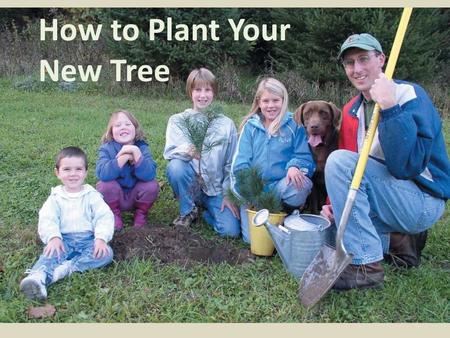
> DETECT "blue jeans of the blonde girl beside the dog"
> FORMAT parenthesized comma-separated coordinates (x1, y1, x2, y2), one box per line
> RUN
(240, 177, 312, 243)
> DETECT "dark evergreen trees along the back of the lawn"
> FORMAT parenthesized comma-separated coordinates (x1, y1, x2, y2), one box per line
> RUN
(0, 8, 450, 106)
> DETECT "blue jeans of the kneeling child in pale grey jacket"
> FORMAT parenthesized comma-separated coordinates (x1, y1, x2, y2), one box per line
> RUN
(166, 159, 240, 237)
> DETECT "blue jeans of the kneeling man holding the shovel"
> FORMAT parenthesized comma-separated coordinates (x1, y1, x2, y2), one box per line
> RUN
(325, 150, 445, 265)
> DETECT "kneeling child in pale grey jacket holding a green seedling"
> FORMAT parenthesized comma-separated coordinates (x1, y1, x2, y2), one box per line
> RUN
(164, 68, 240, 237)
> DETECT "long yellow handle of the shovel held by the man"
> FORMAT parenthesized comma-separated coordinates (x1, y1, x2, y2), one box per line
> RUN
(350, 7, 412, 190)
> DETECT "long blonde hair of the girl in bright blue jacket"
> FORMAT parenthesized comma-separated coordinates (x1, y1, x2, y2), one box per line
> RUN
(239, 77, 289, 135)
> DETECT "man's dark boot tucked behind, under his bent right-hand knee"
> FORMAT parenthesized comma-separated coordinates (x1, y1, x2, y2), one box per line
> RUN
(384, 230, 428, 268)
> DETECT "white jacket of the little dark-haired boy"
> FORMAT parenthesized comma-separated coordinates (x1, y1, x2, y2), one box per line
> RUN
(38, 184, 114, 244)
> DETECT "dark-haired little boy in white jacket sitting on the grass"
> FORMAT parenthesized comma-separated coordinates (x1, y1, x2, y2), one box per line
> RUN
(20, 147, 114, 301)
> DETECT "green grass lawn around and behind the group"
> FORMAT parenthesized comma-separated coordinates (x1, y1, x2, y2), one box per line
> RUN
(0, 80, 450, 322)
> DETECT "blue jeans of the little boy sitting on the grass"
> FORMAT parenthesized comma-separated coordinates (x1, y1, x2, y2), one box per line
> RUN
(30, 232, 113, 285)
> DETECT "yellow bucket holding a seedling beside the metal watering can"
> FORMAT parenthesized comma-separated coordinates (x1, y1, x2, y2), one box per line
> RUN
(247, 209, 286, 256)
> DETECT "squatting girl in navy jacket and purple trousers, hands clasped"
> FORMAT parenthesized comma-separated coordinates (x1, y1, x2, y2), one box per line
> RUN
(95, 110, 159, 230)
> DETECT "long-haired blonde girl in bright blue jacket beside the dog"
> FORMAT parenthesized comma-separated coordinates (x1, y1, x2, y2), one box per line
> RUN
(231, 78, 315, 243)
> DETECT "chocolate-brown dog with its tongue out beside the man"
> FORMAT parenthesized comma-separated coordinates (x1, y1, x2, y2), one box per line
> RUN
(294, 101, 341, 214)
